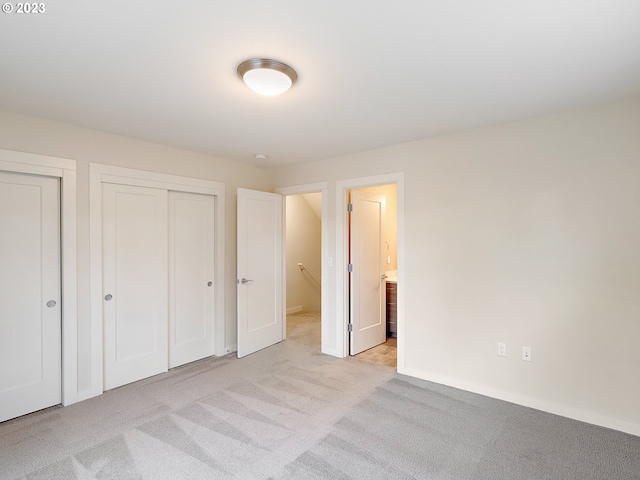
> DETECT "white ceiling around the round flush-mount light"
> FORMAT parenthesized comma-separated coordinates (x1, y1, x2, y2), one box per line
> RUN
(0, 0, 640, 166)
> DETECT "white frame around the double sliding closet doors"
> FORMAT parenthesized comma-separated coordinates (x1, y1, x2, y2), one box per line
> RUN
(86, 163, 229, 398)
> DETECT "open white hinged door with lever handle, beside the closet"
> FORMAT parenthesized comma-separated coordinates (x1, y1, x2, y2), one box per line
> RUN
(237, 188, 284, 357)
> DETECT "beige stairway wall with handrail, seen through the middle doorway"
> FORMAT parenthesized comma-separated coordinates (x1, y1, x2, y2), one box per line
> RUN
(286, 193, 322, 312)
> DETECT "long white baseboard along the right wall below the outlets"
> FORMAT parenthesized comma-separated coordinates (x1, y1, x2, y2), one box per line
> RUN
(398, 367, 640, 436)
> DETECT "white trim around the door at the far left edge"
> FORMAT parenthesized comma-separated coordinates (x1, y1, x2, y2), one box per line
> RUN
(0, 149, 79, 405)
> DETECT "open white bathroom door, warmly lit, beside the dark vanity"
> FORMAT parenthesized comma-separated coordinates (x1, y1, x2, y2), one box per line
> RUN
(349, 190, 387, 355)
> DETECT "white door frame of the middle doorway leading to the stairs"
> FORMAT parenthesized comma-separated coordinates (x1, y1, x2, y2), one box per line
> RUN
(276, 182, 330, 357)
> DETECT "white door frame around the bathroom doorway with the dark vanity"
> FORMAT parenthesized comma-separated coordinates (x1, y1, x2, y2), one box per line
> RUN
(336, 172, 406, 364)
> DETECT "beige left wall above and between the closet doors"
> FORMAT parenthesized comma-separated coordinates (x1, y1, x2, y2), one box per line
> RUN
(0, 111, 273, 391)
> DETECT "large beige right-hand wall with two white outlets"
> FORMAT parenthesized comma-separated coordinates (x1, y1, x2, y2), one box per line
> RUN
(275, 97, 640, 434)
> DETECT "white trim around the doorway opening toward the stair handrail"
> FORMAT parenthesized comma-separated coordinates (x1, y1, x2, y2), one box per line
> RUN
(276, 182, 330, 357)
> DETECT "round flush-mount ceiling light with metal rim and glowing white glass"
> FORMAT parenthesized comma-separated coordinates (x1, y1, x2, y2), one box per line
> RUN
(238, 58, 298, 96)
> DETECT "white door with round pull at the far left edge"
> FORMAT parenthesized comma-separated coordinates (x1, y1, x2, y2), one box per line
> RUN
(0, 173, 61, 422)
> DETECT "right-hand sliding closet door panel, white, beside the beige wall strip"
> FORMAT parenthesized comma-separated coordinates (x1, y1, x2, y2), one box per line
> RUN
(169, 192, 215, 368)
